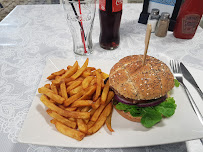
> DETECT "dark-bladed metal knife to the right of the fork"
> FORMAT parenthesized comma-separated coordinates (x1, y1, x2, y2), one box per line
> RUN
(180, 62, 203, 100)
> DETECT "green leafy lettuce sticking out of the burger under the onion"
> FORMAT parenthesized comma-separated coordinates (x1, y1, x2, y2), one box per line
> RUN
(116, 97, 177, 128)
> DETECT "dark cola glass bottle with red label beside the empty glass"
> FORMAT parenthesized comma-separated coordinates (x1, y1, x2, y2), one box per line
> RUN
(99, 0, 123, 50)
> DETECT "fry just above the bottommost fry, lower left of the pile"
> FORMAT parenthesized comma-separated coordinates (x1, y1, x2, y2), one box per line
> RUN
(47, 109, 76, 128)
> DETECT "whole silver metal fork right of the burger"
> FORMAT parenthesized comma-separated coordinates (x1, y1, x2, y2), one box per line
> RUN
(170, 60, 203, 125)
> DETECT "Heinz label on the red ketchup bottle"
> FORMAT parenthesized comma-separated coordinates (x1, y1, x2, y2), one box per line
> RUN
(182, 14, 200, 34)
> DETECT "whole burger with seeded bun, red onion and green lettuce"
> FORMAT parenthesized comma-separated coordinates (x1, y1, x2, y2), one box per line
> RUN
(109, 55, 176, 128)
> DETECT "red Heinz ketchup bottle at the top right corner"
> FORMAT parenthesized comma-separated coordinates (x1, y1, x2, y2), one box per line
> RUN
(173, 0, 203, 39)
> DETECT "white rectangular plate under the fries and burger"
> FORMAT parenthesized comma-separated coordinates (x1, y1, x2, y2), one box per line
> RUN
(18, 59, 203, 148)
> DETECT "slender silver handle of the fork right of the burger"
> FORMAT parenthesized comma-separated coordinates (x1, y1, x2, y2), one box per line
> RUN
(181, 83, 203, 125)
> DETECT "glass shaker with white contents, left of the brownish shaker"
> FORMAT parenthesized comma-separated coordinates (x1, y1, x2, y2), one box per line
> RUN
(148, 8, 160, 33)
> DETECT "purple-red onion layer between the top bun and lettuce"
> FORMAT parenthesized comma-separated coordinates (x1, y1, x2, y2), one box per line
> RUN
(114, 94, 167, 107)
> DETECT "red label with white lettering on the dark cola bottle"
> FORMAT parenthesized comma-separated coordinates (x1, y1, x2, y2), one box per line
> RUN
(99, 0, 123, 12)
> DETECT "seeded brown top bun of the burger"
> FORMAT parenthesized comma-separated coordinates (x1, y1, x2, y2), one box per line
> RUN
(109, 55, 174, 100)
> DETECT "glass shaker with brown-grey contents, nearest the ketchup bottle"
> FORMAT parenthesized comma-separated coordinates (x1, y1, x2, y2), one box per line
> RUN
(155, 12, 170, 37)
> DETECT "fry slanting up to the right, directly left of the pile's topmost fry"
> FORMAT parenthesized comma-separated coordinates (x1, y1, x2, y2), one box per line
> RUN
(52, 61, 78, 84)
